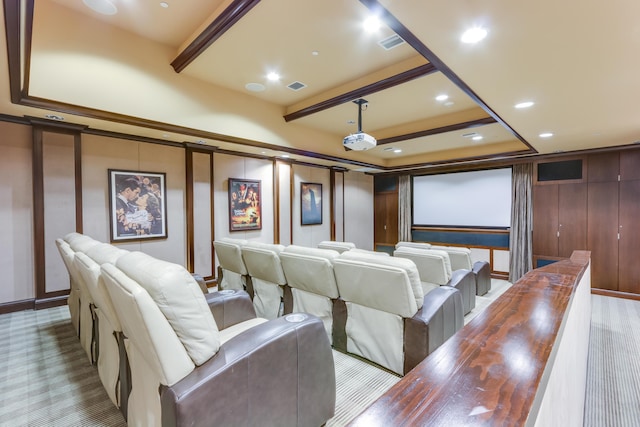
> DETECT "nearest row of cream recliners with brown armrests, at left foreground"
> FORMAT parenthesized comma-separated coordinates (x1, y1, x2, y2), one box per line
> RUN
(56, 233, 336, 426)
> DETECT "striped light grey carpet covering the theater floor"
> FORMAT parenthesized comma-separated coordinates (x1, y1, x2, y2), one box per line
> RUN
(8, 282, 640, 427)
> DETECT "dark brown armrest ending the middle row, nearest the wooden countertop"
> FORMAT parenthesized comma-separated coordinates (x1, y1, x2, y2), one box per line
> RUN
(404, 286, 464, 375)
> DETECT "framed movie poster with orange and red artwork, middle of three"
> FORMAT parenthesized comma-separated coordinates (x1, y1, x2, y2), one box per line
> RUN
(229, 178, 262, 231)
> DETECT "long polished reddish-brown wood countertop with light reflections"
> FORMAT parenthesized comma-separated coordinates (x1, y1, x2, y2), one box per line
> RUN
(349, 251, 590, 427)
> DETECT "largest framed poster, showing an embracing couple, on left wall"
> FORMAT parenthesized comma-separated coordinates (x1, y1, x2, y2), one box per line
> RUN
(109, 169, 167, 242)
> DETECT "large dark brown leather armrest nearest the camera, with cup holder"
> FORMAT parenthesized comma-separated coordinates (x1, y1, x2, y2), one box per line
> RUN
(160, 313, 336, 427)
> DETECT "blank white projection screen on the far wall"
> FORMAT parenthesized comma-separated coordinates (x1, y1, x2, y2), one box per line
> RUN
(413, 168, 511, 228)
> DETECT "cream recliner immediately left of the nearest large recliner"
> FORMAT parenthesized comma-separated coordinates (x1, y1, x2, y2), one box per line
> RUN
(74, 243, 129, 418)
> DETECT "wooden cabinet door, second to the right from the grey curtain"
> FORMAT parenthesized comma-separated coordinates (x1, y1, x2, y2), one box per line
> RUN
(558, 183, 587, 258)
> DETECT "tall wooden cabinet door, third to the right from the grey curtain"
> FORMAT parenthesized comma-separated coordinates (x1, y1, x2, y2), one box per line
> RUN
(587, 181, 618, 290)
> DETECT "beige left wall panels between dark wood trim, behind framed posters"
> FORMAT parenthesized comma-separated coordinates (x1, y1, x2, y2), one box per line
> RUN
(0, 122, 373, 304)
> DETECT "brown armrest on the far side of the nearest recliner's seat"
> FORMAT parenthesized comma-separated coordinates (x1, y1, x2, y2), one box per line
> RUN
(205, 290, 256, 330)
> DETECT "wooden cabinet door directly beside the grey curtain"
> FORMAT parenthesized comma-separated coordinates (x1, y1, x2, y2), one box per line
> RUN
(533, 185, 558, 257)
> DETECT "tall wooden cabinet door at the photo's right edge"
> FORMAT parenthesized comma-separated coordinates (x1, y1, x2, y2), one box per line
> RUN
(616, 180, 640, 294)
